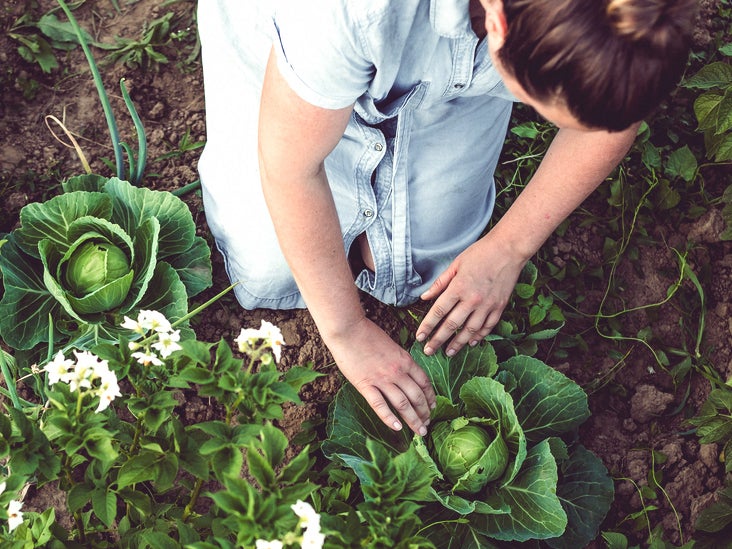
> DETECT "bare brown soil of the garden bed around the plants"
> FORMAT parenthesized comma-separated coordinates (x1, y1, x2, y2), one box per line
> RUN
(0, 0, 732, 544)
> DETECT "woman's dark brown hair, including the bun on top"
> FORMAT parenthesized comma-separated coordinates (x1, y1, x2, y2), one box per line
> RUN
(498, 0, 696, 130)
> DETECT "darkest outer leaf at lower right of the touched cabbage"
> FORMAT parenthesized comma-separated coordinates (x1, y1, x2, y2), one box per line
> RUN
(547, 446, 615, 549)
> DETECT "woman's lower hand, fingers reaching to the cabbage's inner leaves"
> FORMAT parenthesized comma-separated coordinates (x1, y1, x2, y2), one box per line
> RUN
(326, 317, 435, 436)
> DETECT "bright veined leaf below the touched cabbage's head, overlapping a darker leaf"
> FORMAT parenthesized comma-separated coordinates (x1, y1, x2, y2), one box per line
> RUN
(471, 440, 567, 541)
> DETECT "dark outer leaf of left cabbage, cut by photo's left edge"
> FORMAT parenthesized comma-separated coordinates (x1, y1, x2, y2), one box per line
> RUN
(0, 234, 61, 349)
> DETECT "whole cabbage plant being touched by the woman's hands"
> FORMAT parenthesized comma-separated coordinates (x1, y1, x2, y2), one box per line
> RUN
(323, 344, 614, 548)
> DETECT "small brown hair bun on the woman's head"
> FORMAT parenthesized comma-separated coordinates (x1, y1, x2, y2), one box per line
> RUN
(605, 0, 696, 46)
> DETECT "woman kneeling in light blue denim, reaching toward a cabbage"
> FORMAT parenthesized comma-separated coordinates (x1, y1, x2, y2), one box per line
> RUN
(198, 0, 695, 434)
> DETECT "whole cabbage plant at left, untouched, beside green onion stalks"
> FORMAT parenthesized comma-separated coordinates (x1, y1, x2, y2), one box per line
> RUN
(0, 175, 211, 350)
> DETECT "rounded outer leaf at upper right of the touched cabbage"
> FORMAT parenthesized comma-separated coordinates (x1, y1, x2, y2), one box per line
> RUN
(499, 356, 590, 441)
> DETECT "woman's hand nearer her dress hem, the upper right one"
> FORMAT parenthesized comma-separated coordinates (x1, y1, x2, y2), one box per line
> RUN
(417, 233, 526, 356)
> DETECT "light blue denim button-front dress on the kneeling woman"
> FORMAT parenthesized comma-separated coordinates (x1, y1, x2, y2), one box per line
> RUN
(194, 0, 514, 308)
